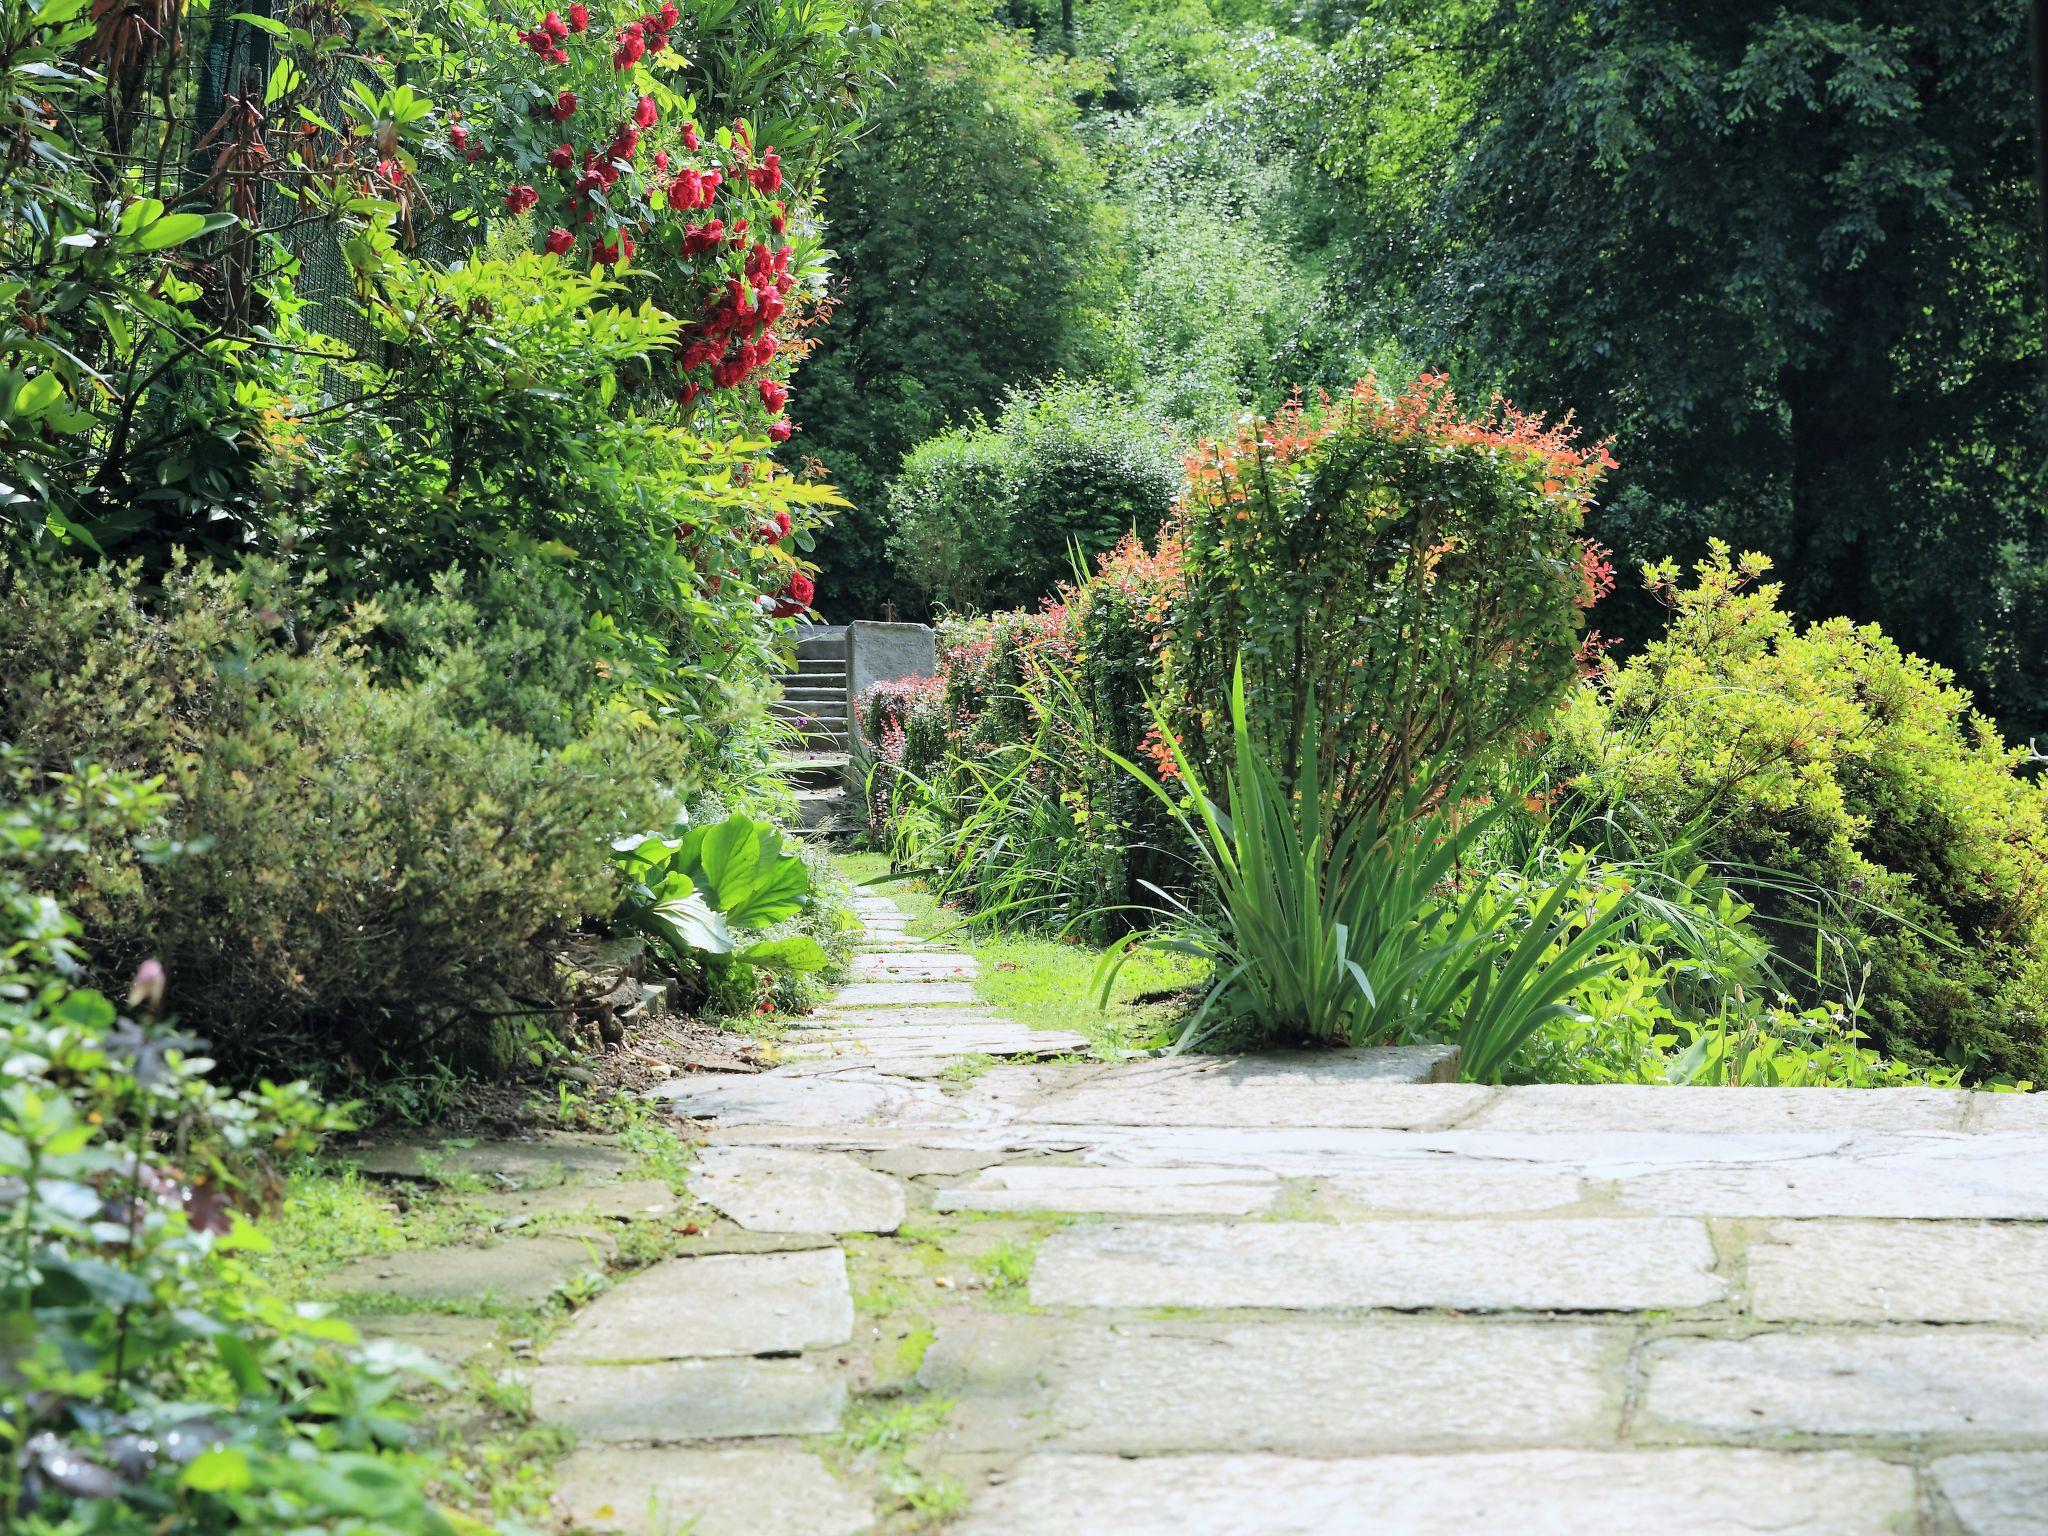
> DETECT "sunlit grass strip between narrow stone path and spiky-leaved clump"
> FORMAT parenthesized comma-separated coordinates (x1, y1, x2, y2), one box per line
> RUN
(836, 854, 1206, 1053)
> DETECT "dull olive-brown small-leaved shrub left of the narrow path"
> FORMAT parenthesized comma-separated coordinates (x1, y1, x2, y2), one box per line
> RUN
(0, 563, 690, 1075)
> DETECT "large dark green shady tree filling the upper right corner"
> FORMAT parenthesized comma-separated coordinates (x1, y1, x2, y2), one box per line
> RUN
(1333, 0, 2048, 727)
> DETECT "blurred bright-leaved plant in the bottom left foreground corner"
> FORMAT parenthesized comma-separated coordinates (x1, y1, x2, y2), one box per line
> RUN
(0, 768, 468, 1536)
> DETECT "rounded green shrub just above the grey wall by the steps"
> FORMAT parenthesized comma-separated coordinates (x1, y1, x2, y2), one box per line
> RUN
(889, 383, 1180, 612)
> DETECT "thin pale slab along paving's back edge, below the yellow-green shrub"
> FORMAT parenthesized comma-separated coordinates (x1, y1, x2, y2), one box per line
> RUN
(1464, 1083, 1968, 1135)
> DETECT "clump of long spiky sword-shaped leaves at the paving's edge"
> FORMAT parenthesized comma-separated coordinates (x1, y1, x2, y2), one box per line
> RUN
(1098, 668, 1620, 1081)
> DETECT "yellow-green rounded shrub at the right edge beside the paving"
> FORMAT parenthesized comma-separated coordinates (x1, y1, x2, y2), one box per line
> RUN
(1550, 545, 2048, 1081)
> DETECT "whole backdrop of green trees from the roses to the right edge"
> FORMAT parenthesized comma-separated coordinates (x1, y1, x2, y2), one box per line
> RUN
(801, 0, 2048, 733)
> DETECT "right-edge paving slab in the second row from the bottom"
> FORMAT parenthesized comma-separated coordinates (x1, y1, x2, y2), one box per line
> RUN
(1642, 1329, 2048, 1436)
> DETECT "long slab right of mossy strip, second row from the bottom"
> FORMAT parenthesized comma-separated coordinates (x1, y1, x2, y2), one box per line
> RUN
(918, 1317, 1630, 1458)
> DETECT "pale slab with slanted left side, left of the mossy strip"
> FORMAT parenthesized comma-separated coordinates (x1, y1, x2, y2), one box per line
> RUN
(541, 1247, 854, 1366)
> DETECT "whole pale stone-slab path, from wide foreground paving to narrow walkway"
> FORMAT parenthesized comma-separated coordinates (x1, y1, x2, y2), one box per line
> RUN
(530, 899, 2048, 1536)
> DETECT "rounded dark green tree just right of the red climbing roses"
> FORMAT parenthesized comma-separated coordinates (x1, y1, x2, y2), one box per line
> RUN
(797, 2, 1116, 618)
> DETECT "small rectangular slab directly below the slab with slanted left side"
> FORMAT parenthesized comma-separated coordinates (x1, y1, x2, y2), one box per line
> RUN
(524, 1360, 846, 1444)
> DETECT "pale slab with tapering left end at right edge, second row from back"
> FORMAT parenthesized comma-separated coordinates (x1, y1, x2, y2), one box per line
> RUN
(1616, 1138, 2048, 1221)
